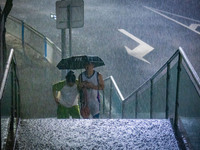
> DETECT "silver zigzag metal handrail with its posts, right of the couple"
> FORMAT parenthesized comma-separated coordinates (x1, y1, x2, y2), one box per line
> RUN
(104, 47, 200, 123)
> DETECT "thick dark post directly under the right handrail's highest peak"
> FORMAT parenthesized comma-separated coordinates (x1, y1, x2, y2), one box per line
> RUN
(174, 53, 182, 127)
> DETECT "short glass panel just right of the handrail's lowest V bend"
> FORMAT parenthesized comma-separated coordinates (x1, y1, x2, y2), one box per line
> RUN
(123, 94, 136, 119)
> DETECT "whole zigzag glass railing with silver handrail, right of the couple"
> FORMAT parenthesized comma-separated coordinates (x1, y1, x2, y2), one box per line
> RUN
(101, 47, 200, 147)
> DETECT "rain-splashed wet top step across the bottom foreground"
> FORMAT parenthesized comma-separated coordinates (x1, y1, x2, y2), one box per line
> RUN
(16, 119, 179, 150)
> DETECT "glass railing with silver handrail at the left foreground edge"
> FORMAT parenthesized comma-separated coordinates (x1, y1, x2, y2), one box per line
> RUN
(0, 49, 20, 149)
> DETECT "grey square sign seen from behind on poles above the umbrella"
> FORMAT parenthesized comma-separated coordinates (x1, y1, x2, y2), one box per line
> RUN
(56, 0, 84, 78)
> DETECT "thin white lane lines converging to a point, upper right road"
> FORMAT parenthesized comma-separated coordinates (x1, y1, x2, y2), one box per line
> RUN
(144, 6, 200, 34)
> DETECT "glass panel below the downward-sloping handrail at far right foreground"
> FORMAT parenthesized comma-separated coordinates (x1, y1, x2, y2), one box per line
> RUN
(178, 62, 200, 150)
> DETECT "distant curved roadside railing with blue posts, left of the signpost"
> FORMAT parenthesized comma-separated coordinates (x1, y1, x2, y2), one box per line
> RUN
(6, 16, 61, 66)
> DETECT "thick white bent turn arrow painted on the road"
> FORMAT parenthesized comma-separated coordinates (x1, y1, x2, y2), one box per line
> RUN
(118, 29, 154, 64)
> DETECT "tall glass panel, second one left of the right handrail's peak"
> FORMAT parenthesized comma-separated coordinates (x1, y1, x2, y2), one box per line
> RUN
(152, 69, 167, 119)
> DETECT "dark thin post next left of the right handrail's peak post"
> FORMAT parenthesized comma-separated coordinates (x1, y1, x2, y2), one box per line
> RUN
(165, 63, 170, 119)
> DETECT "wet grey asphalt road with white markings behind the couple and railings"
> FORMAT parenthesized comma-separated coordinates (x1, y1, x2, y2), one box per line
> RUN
(1, 0, 200, 97)
